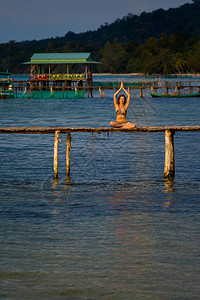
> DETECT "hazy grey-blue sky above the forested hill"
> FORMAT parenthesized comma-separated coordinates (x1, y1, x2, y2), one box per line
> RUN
(0, 0, 192, 43)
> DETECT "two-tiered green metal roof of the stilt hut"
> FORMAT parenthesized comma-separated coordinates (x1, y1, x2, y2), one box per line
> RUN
(24, 53, 99, 64)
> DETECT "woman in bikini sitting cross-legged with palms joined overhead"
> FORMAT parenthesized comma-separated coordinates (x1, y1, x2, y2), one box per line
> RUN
(110, 82, 136, 129)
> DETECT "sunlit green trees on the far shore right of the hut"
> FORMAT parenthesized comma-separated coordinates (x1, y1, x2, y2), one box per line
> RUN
(99, 33, 200, 74)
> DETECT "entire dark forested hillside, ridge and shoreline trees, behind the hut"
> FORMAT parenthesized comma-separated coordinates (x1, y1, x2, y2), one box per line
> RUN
(0, 0, 200, 73)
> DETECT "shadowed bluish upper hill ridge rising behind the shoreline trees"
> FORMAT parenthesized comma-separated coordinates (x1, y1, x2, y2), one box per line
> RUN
(21, 0, 200, 47)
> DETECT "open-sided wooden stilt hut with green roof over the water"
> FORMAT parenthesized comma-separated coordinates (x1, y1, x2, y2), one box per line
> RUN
(24, 53, 99, 98)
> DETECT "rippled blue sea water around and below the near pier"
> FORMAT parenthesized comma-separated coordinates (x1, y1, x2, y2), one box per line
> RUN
(0, 77, 200, 300)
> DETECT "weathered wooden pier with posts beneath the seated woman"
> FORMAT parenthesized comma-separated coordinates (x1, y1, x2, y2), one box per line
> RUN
(0, 125, 200, 178)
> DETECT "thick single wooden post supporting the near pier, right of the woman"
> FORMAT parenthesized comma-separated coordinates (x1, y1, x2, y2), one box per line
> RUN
(164, 130, 175, 178)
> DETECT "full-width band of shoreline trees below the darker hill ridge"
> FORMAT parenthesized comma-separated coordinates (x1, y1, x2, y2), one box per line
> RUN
(0, 33, 200, 74)
